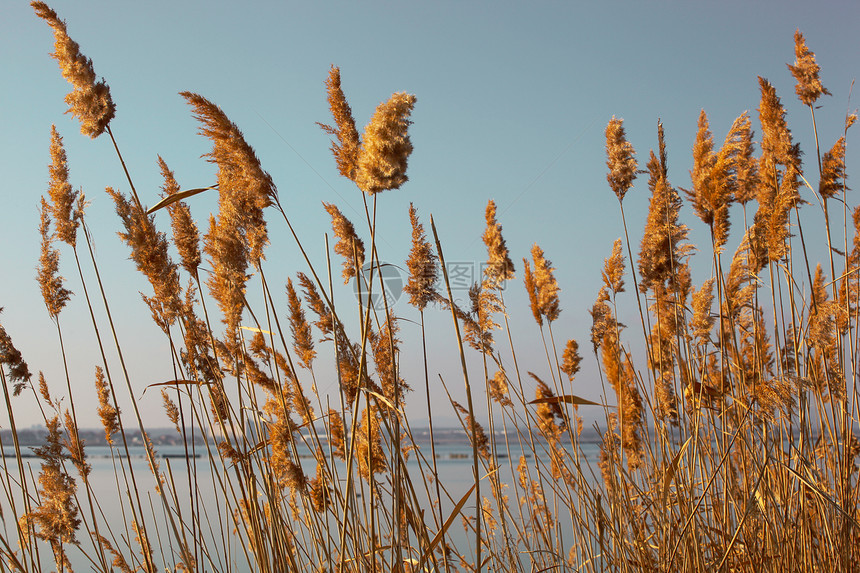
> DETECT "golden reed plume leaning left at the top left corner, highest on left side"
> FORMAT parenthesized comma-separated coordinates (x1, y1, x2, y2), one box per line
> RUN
(30, 2, 116, 139)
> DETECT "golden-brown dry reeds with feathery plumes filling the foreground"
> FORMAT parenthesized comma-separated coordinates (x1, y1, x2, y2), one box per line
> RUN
(0, 2, 860, 572)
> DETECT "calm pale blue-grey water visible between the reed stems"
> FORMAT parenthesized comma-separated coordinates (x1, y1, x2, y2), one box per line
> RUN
(0, 437, 598, 573)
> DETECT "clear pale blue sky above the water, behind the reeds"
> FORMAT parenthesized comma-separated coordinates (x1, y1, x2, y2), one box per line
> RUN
(0, 0, 860, 427)
